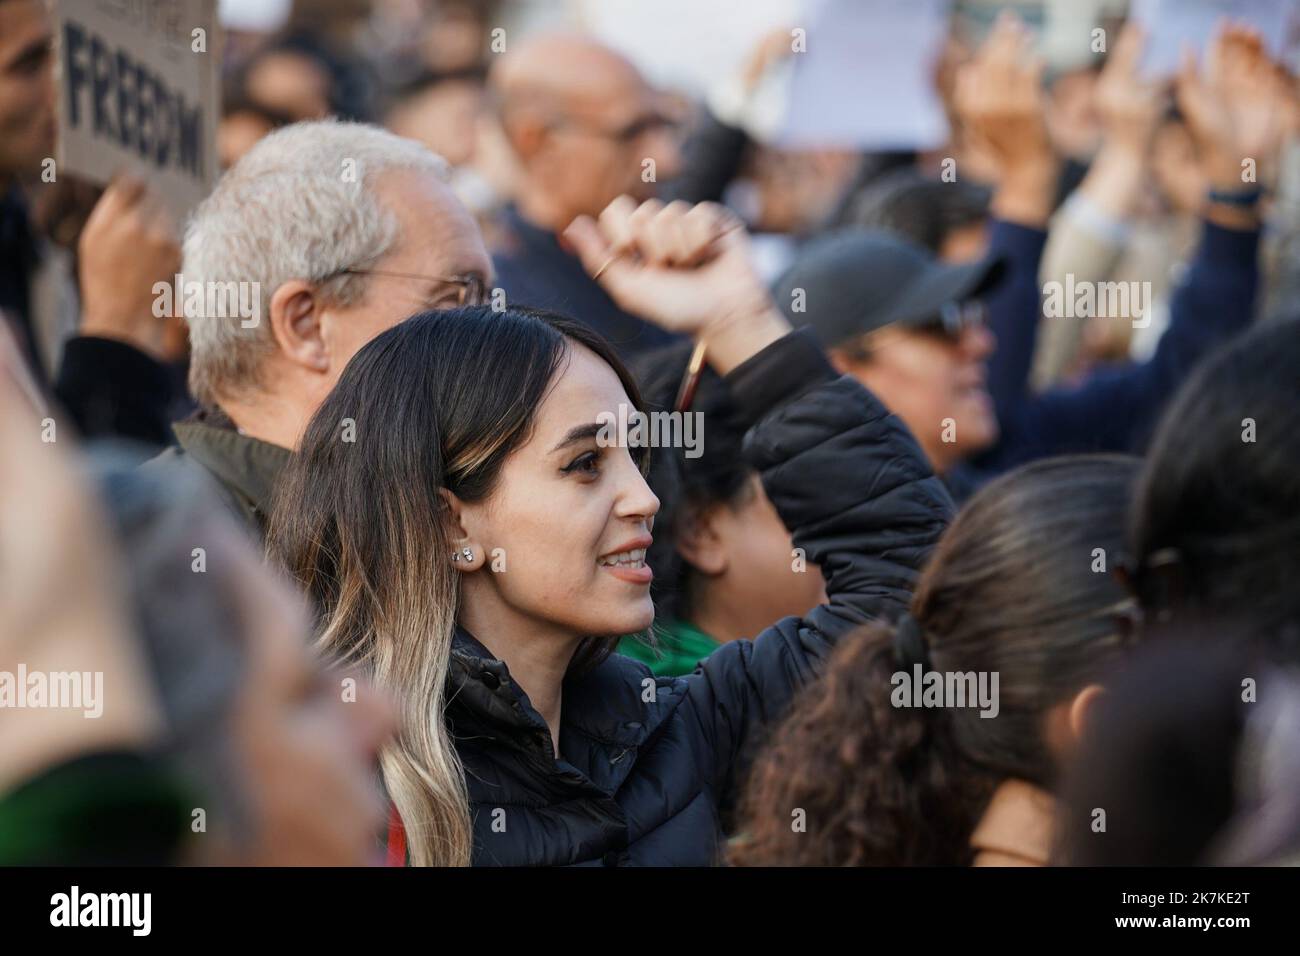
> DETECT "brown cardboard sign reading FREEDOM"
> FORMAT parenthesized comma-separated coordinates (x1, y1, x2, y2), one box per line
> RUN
(53, 0, 221, 225)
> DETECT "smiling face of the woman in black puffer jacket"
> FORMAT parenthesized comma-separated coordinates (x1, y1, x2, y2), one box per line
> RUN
(459, 342, 659, 637)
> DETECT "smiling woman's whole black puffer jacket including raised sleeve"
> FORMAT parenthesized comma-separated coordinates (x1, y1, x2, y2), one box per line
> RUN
(447, 332, 952, 866)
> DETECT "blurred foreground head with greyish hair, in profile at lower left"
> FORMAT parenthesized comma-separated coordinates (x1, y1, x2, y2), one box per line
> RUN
(98, 458, 394, 866)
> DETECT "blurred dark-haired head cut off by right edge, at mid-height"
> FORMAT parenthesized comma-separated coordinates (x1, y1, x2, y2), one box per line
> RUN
(1131, 321, 1300, 662)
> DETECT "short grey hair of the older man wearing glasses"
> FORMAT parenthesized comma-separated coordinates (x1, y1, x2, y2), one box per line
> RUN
(176, 120, 450, 407)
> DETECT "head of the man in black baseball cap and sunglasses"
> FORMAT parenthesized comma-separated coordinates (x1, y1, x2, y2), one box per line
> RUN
(774, 229, 1004, 475)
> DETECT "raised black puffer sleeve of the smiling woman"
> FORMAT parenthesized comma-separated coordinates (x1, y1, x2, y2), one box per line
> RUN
(681, 332, 953, 808)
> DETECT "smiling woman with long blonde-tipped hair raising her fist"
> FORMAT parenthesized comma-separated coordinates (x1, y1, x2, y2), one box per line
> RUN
(269, 199, 950, 865)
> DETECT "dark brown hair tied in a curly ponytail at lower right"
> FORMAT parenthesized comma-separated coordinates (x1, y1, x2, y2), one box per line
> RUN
(731, 455, 1138, 866)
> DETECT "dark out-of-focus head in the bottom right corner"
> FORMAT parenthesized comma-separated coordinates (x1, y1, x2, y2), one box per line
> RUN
(1057, 626, 1300, 866)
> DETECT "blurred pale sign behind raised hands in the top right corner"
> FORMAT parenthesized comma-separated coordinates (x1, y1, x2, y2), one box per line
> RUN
(1130, 0, 1300, 77)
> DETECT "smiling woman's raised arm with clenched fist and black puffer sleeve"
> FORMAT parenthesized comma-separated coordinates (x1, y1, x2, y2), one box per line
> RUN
(569, 200, 952, 806)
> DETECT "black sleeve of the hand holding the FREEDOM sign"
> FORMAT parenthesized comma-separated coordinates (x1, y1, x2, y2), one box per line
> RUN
(55, 336, 174, 449)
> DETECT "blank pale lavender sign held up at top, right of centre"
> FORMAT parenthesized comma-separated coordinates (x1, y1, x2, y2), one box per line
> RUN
(780, 0, 949, 150)
